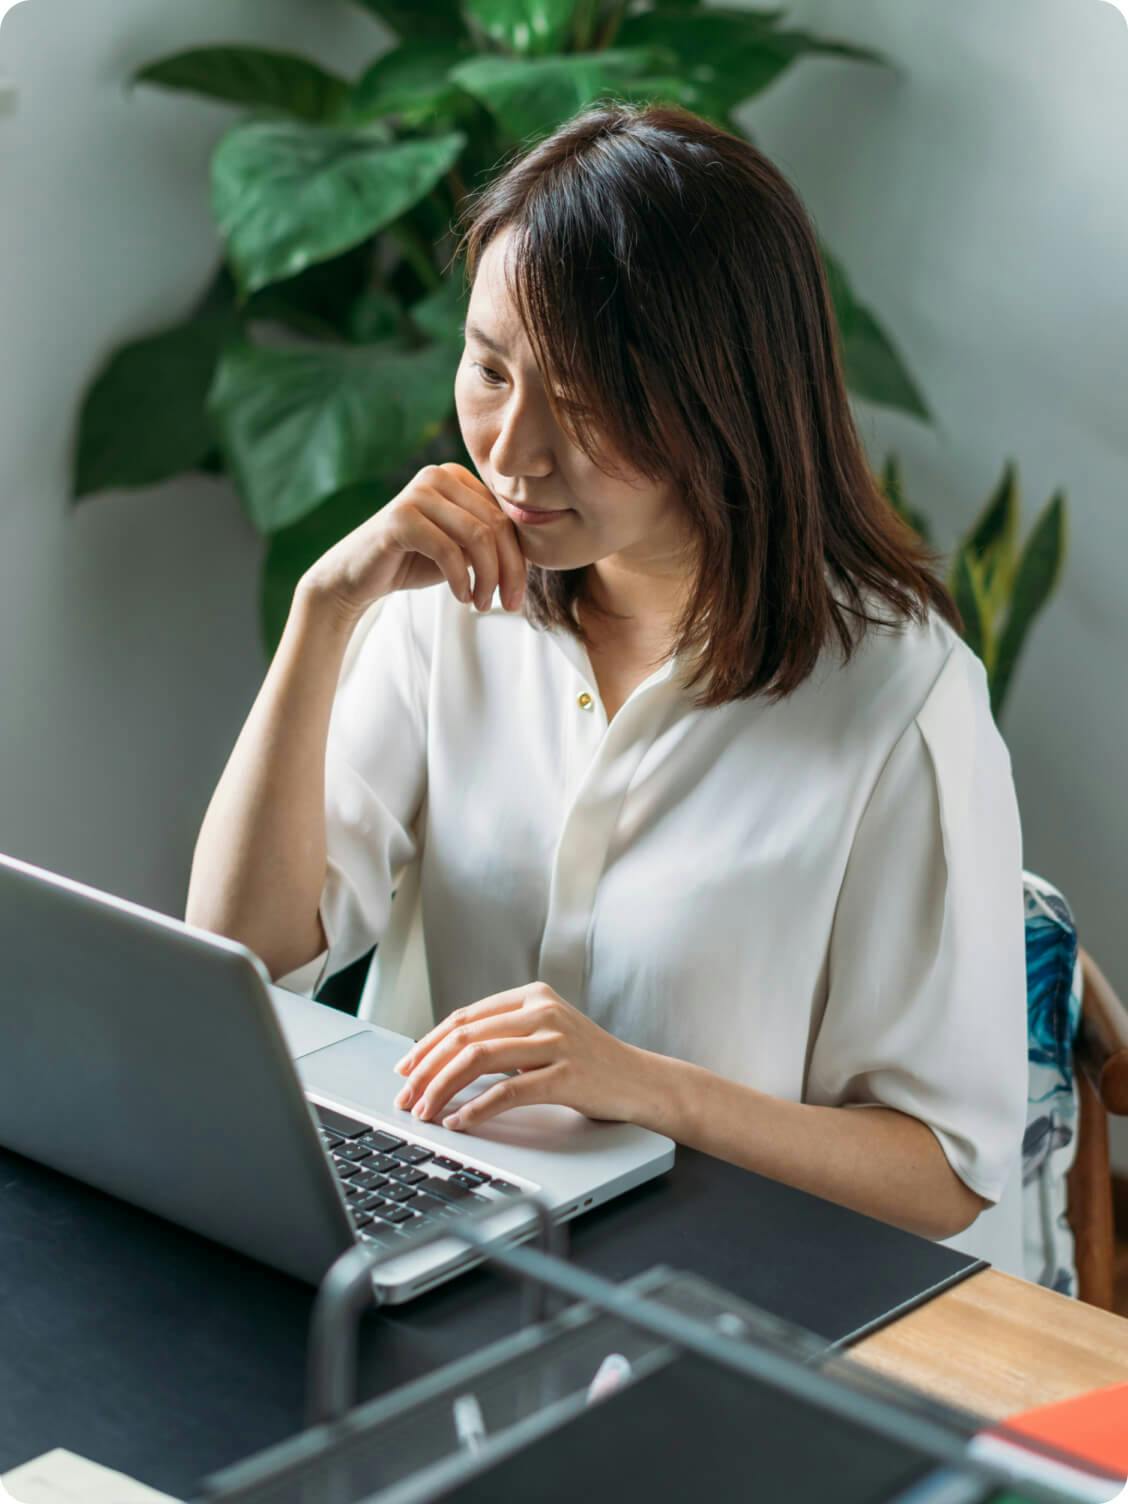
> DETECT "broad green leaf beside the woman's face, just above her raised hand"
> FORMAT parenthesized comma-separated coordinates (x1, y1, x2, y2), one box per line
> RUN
(208, 341, 462, 532)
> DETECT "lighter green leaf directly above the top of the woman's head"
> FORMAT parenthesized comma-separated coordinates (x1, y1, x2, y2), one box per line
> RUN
(450, 47, 696, 141)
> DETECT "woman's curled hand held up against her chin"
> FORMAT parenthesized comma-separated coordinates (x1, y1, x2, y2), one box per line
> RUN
(301, 462, 526, 620)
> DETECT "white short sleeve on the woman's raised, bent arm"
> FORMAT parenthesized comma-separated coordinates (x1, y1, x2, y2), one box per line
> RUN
(274, 591, 427, 996)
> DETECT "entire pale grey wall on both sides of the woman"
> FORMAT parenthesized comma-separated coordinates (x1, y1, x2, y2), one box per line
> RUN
(0, 0, 1128, 1169)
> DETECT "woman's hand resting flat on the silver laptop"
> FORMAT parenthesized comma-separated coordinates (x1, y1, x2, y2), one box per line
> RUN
(396, 982, 647, 1128)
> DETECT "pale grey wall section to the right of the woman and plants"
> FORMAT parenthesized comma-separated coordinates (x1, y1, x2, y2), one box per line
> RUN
(741, 0, 1128, 1170)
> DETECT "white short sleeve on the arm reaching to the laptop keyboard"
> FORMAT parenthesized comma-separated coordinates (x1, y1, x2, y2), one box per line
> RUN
(805, 644, 1027, 1202)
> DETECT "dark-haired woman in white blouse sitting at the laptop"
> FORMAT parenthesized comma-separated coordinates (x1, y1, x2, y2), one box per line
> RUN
(190, 105, 1026, 1272)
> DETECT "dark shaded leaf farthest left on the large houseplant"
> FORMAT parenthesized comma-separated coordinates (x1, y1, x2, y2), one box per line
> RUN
(74, 305, 241, 501)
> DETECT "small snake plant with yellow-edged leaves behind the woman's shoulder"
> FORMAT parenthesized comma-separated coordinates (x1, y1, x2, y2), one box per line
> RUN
(881, 454, 1068, 722)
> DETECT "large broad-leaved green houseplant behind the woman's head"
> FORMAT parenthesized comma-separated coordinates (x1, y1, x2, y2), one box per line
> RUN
(74, 0, 929, 654)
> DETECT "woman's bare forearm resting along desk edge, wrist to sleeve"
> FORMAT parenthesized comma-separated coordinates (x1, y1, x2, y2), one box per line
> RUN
(632, 1050, 991, 1238)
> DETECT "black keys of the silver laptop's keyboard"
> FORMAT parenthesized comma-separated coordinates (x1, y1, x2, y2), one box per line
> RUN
(310, 1102, 520, 1248)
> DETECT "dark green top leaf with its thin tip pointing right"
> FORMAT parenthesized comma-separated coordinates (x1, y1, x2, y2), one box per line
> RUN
(615, 8, 887, 117)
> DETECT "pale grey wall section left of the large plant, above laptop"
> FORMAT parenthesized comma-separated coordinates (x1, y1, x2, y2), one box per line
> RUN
(0, 0, 385, 916)
